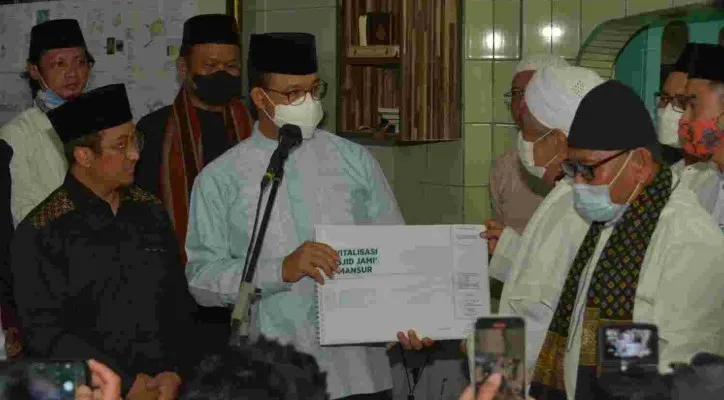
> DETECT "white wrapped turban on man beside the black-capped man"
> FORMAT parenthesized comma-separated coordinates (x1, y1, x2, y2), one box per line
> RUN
(525, 66, 604, 136)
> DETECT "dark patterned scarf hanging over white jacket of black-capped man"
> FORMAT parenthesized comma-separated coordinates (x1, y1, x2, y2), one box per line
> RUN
(530, 166, 672, 400)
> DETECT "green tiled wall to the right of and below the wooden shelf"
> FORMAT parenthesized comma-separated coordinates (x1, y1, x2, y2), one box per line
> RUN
(394, 0, 701, 227)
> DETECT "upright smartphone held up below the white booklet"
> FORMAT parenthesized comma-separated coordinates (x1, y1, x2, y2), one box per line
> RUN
(468, 316, 526, 398)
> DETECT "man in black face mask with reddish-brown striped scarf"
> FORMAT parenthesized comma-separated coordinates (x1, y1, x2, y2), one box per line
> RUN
(136, 14, 251, 354)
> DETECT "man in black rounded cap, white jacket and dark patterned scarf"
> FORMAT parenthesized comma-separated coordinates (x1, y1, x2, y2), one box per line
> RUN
(501, 81, 724, 399)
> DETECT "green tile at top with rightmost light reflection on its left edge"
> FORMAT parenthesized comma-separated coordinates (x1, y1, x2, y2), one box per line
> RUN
(556, 0, 581, 58)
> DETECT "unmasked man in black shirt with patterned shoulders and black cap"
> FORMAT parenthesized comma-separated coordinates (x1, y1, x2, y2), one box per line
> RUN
(11, 85, 195, 398)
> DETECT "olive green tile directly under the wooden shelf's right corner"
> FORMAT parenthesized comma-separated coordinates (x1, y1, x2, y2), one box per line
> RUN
(422, 140, 464, 186)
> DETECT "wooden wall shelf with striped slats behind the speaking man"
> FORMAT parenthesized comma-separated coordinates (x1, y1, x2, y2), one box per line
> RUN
(337, 0, 463, 144)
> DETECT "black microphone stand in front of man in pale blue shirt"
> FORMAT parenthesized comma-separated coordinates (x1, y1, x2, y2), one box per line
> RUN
(229, 151, 289, 347)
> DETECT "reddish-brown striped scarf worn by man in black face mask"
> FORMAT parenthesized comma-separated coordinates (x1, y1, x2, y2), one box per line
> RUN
(159, 89, 251, 264)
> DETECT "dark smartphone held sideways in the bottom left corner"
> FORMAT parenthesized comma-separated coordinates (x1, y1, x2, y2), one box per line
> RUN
(0, 360, 90, 400)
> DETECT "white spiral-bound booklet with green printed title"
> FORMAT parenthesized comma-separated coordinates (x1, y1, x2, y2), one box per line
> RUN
(315, 225, 490, 346)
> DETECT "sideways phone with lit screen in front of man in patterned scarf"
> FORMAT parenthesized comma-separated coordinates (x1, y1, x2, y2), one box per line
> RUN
(598, 323, 659, 377)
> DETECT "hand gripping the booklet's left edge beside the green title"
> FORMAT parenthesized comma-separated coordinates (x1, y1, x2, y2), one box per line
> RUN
(282, 242, 340, 284)
